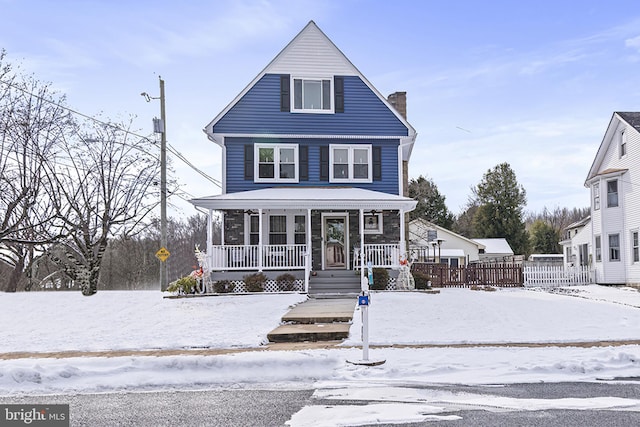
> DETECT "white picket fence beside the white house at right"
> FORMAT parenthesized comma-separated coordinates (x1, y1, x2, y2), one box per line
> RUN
(523, 265, 595, 287)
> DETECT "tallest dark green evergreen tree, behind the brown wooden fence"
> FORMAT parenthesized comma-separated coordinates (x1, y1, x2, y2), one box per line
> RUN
(474, 163, 528, 254)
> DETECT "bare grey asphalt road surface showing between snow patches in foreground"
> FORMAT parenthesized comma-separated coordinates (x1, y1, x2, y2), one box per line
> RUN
(0, 381, 640, 427)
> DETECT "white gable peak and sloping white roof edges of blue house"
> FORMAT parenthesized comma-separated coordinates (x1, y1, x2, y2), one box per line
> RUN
(204, 21, 416, 160)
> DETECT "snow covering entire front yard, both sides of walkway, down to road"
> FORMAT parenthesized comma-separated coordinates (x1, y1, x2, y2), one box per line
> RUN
(0, 285, 640, 395)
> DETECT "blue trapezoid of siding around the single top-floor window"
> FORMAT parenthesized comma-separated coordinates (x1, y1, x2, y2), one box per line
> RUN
(212, 74, 409, 136)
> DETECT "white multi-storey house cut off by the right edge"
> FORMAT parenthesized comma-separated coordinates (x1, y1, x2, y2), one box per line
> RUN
(584, 112, 640, 284)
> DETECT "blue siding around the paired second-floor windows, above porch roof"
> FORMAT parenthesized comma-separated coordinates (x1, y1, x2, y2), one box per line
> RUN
(225, 137, 399, 195)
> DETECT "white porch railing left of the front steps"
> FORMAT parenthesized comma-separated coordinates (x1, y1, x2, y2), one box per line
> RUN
(207, 245, 307, 271)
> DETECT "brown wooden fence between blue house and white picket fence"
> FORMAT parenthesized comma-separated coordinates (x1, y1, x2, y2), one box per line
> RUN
(411, 262, 524, 288)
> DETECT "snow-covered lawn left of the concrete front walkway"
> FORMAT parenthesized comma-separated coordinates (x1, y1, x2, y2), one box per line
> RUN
(0, 291, 306, 353)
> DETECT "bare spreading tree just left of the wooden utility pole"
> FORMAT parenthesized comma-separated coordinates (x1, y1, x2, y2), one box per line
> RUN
(49, 118, 159, 295)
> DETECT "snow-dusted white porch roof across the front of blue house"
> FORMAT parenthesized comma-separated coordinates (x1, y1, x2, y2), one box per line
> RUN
(190, 187, 417, 212)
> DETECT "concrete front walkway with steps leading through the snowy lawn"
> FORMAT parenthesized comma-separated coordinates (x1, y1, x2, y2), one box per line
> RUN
(267, 298, 357, 343)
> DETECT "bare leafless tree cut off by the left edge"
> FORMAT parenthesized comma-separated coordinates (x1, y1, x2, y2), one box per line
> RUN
(0, 52, 71, 292)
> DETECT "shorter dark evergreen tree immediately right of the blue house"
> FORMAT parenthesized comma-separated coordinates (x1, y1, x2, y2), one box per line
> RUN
(409, 175, 454, 229)
